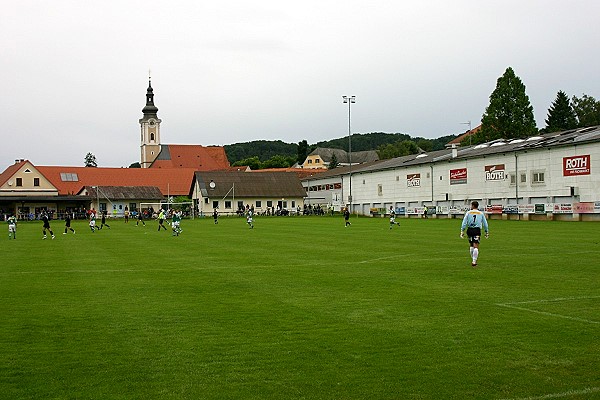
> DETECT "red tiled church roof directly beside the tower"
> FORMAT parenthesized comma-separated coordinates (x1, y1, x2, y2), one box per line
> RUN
(150, 144, 229, 171)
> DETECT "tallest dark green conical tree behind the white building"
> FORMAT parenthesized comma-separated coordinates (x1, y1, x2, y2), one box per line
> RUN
(474, 67, 538, 143)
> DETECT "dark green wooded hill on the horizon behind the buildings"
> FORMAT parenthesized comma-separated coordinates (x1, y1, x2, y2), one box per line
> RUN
(224, 132, 456, 169)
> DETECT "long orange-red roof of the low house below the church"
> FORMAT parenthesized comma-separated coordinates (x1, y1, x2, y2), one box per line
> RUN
(36, 166, 196, 196)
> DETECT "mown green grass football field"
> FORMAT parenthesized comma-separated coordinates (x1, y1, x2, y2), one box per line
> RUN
(0, 217, 600, 400)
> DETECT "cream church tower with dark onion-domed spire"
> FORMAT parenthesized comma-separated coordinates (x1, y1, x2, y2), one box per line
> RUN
(140, 77, 162, 168)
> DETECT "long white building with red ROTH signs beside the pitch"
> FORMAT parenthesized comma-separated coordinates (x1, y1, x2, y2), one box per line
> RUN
(302, 127, 600, 220)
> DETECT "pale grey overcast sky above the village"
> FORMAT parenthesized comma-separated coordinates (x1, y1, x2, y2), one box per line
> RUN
(0, 0, 600, 167)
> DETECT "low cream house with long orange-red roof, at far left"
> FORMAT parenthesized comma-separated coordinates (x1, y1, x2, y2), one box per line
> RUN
(0, 159, 196, 218)
